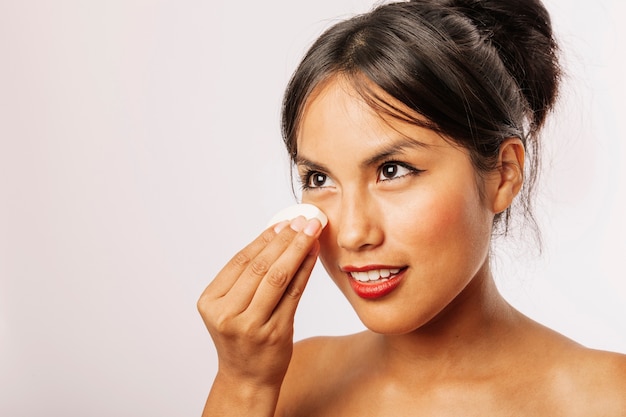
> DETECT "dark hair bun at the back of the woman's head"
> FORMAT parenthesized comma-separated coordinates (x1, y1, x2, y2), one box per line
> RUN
(442, 0, 561, 131)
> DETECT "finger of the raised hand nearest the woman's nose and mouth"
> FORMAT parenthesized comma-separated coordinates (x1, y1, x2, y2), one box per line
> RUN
(249, 219, 322, 318)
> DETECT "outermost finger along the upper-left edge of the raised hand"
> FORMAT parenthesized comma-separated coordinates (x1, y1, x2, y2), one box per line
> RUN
(201, 222, 289, 298)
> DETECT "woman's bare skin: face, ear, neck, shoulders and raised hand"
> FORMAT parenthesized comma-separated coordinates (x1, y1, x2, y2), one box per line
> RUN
(198, 77, 626, 417)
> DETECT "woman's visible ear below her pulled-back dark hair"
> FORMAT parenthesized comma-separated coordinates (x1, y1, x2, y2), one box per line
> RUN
(490, 138, 526, 213)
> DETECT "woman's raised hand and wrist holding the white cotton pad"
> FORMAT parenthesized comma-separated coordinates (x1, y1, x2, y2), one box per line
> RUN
(198, 217, 322, 416)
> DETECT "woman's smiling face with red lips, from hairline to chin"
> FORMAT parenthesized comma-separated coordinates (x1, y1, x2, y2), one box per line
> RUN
(296, 77, 493, 334)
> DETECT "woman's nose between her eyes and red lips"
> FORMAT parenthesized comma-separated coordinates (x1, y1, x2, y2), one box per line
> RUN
(335, 193, 384, 251)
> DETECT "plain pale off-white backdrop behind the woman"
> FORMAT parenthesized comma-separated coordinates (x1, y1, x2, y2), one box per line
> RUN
(0, 0, 626, 417)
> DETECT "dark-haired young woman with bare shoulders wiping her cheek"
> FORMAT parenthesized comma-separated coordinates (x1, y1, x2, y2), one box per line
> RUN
(198, 0, 626, 417)
